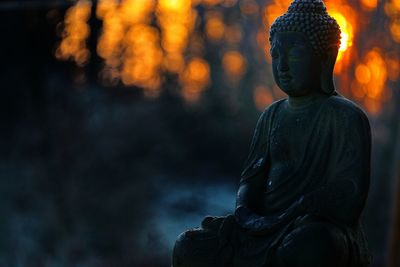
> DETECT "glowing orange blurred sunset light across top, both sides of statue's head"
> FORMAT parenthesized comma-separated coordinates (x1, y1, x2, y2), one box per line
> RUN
(56, 0, 400, 113)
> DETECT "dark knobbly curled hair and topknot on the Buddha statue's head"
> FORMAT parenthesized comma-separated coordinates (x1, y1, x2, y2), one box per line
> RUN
(269, 0, 340, 55)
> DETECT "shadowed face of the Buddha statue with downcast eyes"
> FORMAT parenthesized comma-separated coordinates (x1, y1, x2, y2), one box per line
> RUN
(271, 32, 321, 96)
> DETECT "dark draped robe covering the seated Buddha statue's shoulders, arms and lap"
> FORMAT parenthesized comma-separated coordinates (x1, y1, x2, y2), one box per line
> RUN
(174, 95, 371, 267)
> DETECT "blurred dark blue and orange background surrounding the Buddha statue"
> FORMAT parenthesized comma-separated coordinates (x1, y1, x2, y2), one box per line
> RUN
(0, 0, 400, 267)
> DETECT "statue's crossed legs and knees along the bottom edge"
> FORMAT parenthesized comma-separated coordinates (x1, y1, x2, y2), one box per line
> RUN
(173, 215, 354, 267)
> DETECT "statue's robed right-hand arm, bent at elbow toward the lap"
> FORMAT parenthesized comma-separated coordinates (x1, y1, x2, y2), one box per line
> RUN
(301, 111, 371, 225)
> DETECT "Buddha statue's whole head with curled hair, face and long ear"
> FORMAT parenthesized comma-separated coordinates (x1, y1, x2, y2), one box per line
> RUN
(269, 0, 340, 96)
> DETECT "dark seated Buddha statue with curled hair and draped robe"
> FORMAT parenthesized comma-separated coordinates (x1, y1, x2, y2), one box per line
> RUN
(172, 0, 371, 267)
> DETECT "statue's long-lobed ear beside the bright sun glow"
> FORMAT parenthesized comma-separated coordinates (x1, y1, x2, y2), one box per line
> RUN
(321, 46, 339, 94)
